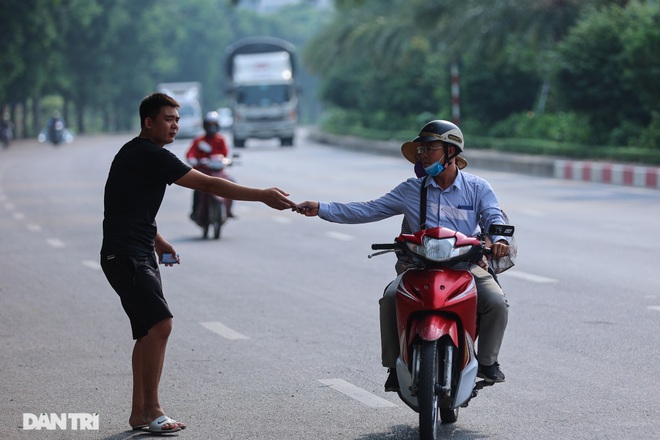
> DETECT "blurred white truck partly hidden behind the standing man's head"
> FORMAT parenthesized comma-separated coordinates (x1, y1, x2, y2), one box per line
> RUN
(157, 81, 204, 138)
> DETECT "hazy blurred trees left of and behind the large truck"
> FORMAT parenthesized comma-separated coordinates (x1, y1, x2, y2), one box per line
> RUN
(0, 0, 327, 135)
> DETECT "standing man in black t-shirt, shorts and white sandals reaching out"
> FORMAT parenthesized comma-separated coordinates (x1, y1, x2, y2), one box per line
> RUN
(101, 93, 296, 433)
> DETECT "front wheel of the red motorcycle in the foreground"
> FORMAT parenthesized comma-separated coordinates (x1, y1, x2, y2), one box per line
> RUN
(417, 341, 439, 440)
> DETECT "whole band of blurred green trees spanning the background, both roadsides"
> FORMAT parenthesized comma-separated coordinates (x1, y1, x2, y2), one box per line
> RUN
(0, 0, 660, 155)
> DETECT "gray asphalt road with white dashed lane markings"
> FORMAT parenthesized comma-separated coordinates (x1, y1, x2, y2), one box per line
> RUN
(0, 131, 660, 440)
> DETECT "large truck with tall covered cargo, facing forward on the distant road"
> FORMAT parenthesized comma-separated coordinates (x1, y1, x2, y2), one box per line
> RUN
(225, 37, 298, 148)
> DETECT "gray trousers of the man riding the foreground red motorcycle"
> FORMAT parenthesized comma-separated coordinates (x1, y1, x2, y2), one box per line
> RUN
(379, 264, 509, 368)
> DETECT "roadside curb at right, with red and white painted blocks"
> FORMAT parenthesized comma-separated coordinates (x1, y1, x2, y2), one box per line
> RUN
(307, 129, 660, 189)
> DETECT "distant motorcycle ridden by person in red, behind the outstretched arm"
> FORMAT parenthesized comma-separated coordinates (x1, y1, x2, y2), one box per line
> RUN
(192, 154, 232, 240)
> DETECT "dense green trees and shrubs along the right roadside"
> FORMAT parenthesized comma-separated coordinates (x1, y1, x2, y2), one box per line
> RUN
(305, 0, 660, 154)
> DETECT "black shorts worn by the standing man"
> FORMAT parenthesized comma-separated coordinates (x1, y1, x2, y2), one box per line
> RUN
(101, 254, 172, 339)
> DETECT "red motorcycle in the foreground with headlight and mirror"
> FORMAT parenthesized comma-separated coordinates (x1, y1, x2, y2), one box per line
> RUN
(369, 225, 514, 440)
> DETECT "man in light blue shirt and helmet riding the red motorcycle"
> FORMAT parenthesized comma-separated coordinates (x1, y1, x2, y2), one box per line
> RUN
(295, 120, 509, 391)
